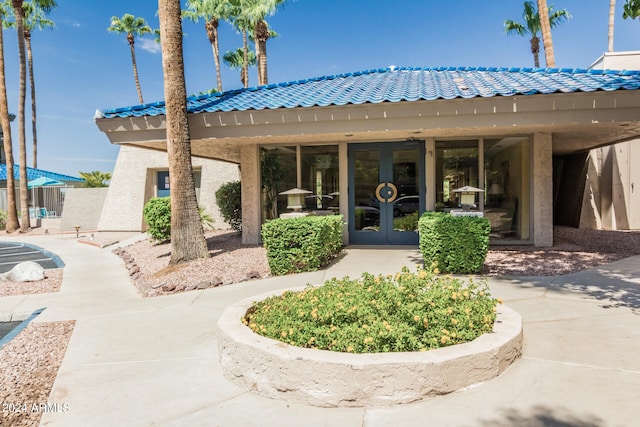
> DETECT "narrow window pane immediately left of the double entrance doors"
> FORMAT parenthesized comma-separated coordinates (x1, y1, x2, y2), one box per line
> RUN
(300, 145, 340, 212)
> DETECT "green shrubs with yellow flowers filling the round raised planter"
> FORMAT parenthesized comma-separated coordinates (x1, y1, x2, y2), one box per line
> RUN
(242, 268, 500, 353)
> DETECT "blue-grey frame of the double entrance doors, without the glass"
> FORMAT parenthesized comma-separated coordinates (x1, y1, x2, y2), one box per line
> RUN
(347, 140, 426, 245)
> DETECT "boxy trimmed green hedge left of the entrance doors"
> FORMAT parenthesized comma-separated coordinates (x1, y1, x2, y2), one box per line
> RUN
(262, 215, 343, 275)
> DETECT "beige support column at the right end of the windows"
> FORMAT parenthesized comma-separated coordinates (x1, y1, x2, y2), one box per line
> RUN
(531, 133, 553, 247)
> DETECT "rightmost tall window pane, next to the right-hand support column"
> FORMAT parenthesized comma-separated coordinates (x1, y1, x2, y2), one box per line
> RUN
(484, 137, 530, 241)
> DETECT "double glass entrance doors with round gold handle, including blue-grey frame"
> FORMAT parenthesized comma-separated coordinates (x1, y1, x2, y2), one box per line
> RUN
(349, 141, 425, 245)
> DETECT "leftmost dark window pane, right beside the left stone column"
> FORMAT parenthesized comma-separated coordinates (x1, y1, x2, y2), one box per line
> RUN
(260, 146, 297, 221)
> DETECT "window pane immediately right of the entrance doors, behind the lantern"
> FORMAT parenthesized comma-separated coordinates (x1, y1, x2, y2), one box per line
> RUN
(436, 141, 480, 211)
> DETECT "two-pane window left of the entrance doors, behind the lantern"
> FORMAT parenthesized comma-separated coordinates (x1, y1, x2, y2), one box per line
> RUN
(260, 145, 340, 221)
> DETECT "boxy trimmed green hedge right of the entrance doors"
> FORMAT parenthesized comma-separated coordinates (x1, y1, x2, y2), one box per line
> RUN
(418, 212, 491, 274)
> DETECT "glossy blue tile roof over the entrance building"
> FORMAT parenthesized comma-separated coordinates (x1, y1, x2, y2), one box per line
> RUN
(97, 67, 640, 118)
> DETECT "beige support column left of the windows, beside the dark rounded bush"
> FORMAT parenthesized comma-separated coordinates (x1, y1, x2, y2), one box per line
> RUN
(240, 145, 262, 245)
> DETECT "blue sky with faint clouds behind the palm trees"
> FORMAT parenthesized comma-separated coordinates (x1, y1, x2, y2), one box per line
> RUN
(4, 0, 640, 176)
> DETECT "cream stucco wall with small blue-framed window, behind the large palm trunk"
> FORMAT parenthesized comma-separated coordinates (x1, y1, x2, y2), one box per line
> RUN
(98, 146, 240, 231)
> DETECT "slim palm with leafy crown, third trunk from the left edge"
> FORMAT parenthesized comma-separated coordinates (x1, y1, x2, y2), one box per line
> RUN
(9, 2, 55, 168)
